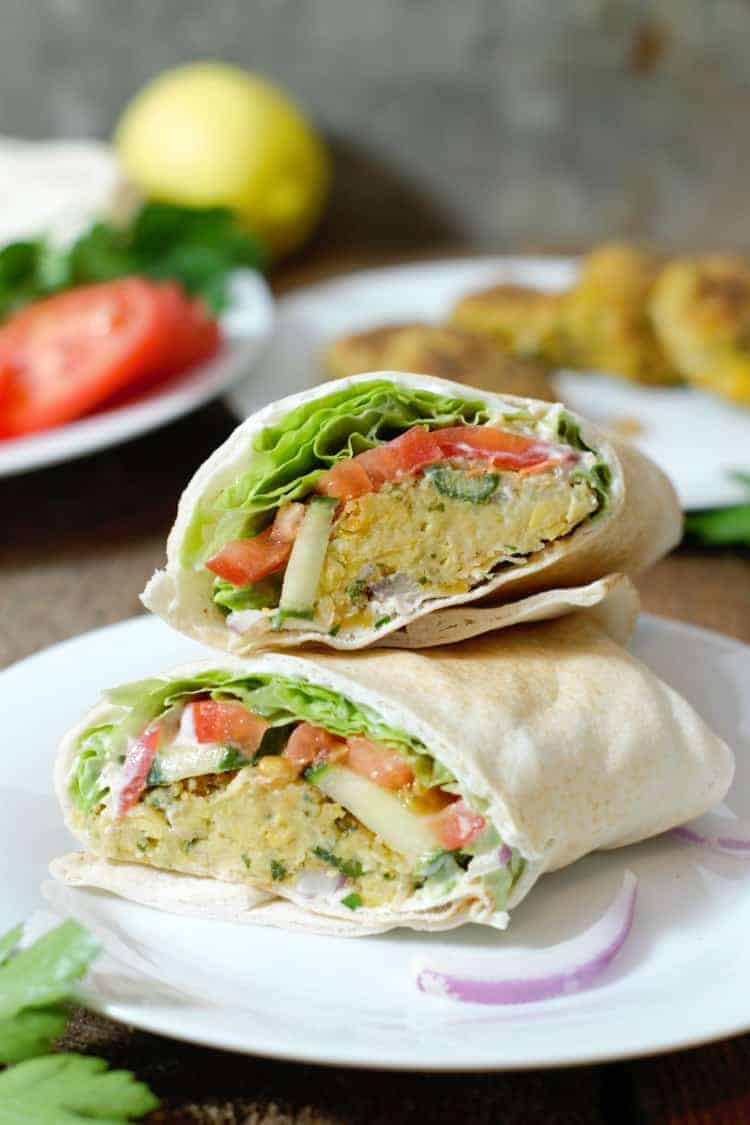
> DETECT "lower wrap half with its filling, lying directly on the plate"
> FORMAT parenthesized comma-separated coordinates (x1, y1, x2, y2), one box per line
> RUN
(52, 613, 733, 935)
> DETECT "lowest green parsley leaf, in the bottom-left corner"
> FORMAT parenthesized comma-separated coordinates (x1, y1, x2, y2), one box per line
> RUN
(0, 1054, 159, 1125)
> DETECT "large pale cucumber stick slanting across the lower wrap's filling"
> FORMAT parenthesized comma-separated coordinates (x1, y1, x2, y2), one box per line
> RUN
(310, 766, 440, 860)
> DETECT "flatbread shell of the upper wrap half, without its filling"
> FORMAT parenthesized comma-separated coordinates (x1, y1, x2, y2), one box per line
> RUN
(142, 371, 681, 655)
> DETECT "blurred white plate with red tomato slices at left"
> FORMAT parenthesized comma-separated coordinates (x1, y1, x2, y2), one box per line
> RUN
(0, 270, 273, 477)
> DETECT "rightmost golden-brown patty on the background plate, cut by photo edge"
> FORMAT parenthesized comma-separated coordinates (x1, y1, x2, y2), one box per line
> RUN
(650, 254, 750, 404)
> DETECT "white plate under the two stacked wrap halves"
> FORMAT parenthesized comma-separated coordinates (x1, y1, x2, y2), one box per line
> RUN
(0, 617, 750, 1070)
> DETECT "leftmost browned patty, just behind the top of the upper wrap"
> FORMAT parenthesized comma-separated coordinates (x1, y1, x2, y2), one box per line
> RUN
(323, 323, 555, 402)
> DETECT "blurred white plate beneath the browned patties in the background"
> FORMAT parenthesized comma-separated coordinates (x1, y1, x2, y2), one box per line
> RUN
(231, 258, 750, 509)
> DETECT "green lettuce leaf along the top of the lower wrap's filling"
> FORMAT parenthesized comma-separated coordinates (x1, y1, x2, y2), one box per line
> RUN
(71, 669, 454, 810)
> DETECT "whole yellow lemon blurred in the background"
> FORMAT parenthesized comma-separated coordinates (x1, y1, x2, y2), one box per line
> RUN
(115, 62, 331, 255)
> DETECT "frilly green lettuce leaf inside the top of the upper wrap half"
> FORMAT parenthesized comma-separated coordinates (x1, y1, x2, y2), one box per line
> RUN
(181, 379, 488, 567)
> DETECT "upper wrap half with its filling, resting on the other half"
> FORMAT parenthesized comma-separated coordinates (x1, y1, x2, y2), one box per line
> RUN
(143, 372, 681, 655)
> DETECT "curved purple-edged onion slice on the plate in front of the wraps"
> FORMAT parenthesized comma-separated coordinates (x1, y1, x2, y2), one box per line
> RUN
(415, 871, 638, 1004)
